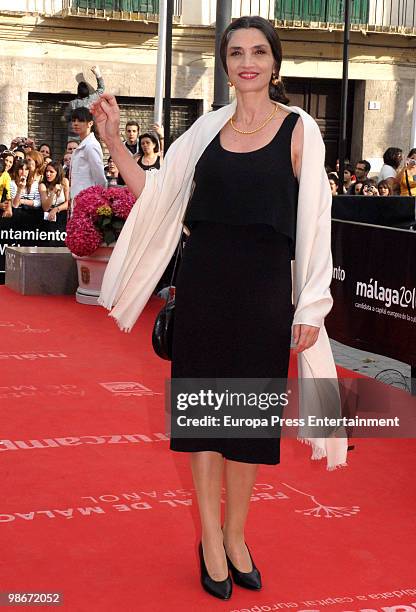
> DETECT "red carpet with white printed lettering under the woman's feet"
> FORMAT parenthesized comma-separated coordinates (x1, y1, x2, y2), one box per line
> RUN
(0, 287, 416, 612)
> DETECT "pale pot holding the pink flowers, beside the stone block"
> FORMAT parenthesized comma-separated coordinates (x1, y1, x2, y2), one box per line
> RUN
(73, 243, 115, 306)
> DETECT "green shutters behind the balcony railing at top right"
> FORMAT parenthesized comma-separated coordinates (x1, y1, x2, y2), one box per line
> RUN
(275, 0, 369, 23)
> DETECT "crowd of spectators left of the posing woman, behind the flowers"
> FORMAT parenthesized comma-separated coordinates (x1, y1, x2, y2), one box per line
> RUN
(0, 83, 163, 225)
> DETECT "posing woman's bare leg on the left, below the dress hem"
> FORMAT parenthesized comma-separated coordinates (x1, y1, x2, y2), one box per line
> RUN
(191, 451, 228, 580)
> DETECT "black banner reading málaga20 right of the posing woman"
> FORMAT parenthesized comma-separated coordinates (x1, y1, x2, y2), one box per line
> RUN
(326, 221, 416, 366)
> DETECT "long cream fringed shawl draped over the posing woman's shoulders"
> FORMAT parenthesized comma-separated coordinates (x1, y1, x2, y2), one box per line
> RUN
(99, 101, 347, 469)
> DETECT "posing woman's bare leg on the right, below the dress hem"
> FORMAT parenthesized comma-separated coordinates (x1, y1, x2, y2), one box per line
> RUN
(223, 459, 258, 572)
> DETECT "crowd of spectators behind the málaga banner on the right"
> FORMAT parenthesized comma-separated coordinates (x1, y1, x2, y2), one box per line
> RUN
(327, 147, 416, 196)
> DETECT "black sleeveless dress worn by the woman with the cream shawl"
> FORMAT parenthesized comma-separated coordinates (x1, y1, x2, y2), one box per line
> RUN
(170, 113, 299, 465)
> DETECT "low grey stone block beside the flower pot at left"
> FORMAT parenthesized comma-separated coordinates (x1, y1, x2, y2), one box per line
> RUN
(5, 246, 78, 295)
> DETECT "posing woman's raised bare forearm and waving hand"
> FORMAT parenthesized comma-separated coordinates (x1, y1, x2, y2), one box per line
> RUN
(90, 93, 146, 198)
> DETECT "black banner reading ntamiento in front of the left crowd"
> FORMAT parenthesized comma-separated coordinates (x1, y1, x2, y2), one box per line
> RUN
(0, 209, 67, 285)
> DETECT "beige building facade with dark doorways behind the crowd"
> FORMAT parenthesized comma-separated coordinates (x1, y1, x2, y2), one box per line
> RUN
(0, 0, 416, 170)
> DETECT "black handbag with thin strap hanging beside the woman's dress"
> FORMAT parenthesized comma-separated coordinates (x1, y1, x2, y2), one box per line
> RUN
(152, 234, 183, 361)
